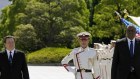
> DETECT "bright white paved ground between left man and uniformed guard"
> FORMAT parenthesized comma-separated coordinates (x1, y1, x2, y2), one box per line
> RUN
(28, 66, 74, 79)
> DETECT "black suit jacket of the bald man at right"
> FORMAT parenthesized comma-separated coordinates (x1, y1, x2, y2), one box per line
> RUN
(111, 38, 140, 79)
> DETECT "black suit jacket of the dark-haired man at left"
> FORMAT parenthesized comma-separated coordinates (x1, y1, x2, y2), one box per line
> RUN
(0, 50, 29, 79)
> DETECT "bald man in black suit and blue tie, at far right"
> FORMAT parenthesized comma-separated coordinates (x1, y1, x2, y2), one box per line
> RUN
(111, 25, 140, 79)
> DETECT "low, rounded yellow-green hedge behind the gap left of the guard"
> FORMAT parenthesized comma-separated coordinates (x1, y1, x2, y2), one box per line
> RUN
(27, 47, 71, 64)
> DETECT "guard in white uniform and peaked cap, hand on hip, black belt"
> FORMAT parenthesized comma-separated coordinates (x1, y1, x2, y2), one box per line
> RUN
(61, 32, 100, 79)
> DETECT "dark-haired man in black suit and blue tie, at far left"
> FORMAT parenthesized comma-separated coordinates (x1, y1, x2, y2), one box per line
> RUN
(0, 36, 29, 79)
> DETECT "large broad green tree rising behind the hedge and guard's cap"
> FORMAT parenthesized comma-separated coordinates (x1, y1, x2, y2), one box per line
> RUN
(17, 0, 88, 47)
